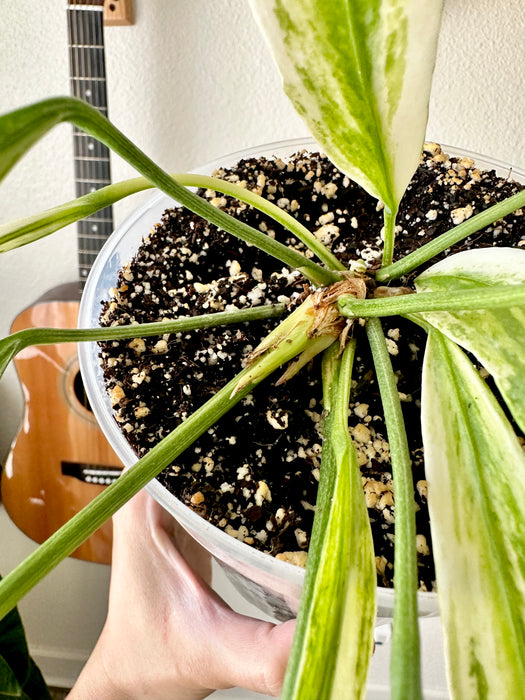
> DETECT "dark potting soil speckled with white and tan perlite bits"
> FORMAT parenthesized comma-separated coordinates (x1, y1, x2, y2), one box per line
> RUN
(100, 144, 525, 590)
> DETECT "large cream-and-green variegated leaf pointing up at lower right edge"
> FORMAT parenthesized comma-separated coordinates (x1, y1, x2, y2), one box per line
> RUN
(422, 329, 525, 700)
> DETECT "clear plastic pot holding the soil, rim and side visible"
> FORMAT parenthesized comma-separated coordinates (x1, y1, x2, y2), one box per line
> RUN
(79, 139, 523, 620)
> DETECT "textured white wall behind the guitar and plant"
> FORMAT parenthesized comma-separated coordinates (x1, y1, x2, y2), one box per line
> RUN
(0, 0, 525, 688)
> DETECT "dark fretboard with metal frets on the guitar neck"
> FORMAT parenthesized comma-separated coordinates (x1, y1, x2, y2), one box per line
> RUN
(67, 0, 113, 286)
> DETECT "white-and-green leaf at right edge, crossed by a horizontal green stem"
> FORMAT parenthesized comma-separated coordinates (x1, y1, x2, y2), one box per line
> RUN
(415, 248, 525, 432)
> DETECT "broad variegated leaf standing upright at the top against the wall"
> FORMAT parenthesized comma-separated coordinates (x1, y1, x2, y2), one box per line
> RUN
(251, 0, 443, 252)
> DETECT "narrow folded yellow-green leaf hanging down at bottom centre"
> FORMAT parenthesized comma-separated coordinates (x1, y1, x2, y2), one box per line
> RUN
(281, 341, 376, 700)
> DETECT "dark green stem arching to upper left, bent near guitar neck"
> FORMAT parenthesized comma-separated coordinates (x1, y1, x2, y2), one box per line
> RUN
(0, 97, 339, 285)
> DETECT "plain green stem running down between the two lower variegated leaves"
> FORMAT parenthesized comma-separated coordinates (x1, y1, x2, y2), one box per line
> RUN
(366, 319, 423, 700)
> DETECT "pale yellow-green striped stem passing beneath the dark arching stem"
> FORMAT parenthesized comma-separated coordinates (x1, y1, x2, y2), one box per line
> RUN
(0, 173, 346, 270)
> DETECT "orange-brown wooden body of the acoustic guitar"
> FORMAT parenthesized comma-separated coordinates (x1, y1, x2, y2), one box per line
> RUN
(2, 284, 122, 564)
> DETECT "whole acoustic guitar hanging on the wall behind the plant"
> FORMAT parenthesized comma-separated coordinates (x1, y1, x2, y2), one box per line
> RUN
(2, 0, 131, 564)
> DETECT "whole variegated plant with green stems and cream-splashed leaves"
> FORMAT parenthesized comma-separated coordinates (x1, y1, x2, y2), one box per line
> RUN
(0, 0, 525, 698)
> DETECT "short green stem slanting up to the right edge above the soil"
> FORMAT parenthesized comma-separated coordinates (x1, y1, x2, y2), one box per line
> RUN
(376, 190, 525, 282)
